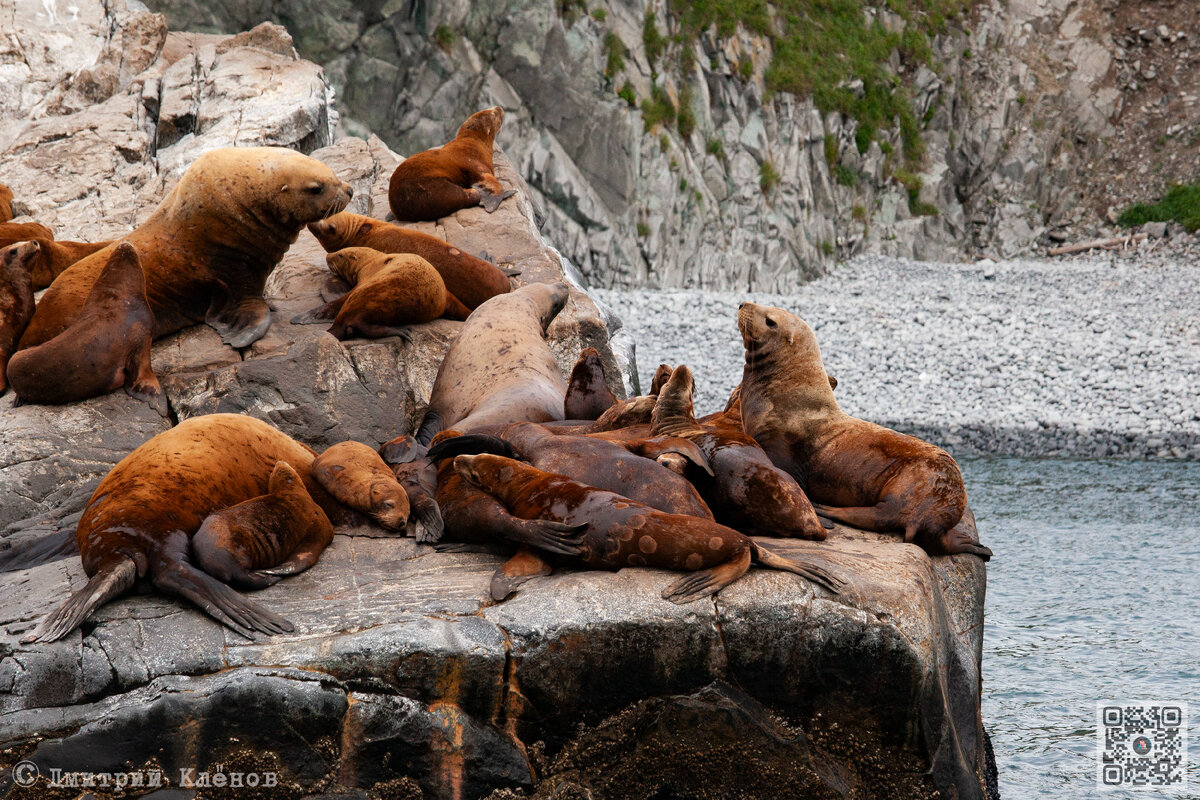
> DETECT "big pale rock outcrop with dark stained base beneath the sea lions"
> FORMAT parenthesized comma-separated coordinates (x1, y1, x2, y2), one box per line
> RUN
(0, 2, 995, 800)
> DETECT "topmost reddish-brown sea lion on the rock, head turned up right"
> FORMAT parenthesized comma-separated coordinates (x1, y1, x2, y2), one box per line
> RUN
(388, 106, 516, 222)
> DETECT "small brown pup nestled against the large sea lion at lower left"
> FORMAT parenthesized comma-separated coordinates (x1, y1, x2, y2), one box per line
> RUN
(192, 461, 334, 589)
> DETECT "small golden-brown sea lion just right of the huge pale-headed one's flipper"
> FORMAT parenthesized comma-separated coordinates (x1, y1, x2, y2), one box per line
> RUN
(292, 247, 470, 339)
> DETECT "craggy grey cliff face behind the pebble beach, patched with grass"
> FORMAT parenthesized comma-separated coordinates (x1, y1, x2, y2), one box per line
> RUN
(140, 0, 1196, 291)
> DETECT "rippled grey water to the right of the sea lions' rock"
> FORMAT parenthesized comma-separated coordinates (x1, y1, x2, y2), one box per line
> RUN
(961, 458, 1200, 800)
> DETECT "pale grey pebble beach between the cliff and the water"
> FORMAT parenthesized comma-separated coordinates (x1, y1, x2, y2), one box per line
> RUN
(594, 252, 1200, 459)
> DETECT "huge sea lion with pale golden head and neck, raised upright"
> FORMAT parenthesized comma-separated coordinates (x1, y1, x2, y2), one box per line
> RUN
(20, 148, 353, 349)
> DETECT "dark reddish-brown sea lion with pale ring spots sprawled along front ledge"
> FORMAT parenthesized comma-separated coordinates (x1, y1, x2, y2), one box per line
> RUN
(454, 453, 842, 603)
